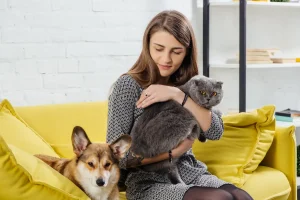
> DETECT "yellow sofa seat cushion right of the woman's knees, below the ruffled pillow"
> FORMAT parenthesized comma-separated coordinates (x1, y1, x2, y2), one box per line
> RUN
(242, 166, 291, 200)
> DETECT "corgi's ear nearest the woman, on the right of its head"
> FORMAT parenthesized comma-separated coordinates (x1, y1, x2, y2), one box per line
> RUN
(109, 134, 131, 160)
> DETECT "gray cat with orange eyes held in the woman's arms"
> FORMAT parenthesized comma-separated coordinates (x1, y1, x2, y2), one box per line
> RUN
(130, 75, 223, 184)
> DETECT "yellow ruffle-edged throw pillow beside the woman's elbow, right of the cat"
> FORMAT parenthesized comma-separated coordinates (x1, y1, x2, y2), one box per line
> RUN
(193, 105, 275, 187)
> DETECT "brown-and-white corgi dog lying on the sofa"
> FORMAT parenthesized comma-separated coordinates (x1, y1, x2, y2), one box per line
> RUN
(35, 126, 131, 200)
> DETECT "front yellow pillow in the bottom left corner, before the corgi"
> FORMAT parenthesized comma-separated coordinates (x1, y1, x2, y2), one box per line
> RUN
(0, 136, 89, 200)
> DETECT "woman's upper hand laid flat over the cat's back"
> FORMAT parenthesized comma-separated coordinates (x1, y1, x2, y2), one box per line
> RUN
(136, 85, 184, 108)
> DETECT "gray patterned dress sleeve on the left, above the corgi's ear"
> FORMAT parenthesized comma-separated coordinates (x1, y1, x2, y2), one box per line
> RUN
(106, 75, 139, 169)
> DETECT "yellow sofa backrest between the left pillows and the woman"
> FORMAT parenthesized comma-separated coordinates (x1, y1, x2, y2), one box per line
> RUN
(15, 101, 107, 158)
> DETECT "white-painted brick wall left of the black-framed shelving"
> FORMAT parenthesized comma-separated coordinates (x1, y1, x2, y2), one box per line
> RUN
(0, 0, 196, 105)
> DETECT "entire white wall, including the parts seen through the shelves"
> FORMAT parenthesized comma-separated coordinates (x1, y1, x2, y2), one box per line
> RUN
(0, 0, 300, 112)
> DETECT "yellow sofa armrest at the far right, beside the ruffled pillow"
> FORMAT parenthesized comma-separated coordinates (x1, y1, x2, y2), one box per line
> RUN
(261, 126, 297, 200)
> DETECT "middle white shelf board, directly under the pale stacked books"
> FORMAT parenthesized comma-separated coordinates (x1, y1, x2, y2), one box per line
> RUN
(210, 63, 300, 69)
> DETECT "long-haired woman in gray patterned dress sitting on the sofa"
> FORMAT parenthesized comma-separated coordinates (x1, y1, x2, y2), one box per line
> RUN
(107, 11, 252, 200)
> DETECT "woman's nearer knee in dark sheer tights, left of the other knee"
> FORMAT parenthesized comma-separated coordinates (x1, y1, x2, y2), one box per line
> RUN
(183, 187, 234, 200)
